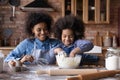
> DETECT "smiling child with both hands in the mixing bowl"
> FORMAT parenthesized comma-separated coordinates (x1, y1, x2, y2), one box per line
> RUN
(54, 15, 98, 62)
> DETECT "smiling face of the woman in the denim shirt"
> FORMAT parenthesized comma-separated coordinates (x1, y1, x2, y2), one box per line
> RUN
(32, 22, 49, 41)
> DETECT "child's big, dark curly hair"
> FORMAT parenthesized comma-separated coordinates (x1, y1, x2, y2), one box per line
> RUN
(53, 15, 85, 40)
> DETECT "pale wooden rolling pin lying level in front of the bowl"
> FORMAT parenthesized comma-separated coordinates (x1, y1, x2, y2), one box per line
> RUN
(36, 69, 98, 76)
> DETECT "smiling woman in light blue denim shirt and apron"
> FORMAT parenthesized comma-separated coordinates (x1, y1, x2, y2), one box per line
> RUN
(4, 12, 59, 65)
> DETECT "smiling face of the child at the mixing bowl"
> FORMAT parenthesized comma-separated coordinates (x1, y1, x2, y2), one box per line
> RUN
(61, 29, 74, 46)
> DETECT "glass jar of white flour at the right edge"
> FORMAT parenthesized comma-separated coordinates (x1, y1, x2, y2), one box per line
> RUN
(105, 48, 120, 70)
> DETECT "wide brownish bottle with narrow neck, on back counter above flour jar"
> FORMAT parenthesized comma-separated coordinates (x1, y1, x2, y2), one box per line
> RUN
(104, 31, 112, 47)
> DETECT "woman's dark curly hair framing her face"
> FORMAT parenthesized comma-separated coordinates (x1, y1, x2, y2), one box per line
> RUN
(26, 12, 53, 36)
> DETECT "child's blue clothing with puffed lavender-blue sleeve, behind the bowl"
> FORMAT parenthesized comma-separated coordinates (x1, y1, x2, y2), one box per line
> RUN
(57, 39, 98, 62)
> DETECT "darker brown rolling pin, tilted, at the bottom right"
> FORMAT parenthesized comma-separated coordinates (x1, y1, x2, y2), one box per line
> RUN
(66, 70, 120, 80)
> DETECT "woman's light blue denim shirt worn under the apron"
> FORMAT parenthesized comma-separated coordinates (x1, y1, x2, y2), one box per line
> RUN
(4, 38, 60, 64)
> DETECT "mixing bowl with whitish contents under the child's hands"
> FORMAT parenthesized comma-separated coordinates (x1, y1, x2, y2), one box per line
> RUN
(56, 55, 81, 68)
